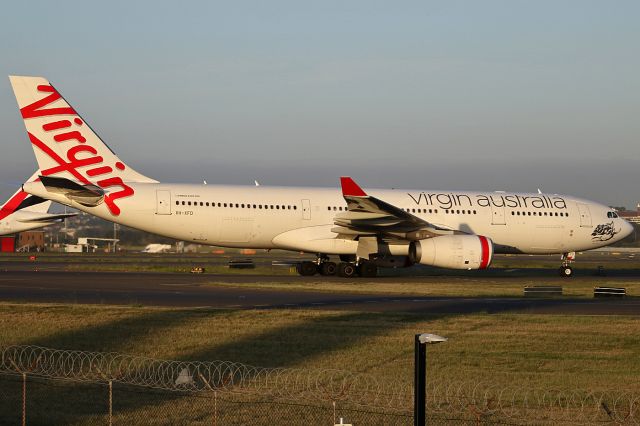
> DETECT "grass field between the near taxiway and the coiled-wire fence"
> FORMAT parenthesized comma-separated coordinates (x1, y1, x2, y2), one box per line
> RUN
(0, 303, 640, 391)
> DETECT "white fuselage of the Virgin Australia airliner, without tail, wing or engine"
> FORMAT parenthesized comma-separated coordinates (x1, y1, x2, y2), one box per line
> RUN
(25, 183, 630, 254)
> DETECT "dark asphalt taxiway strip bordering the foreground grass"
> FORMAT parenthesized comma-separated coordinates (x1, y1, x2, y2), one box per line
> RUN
(0, 271, 640, 315)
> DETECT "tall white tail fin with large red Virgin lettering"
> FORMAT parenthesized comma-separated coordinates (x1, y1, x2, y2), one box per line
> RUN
(9, 76, 157, 216)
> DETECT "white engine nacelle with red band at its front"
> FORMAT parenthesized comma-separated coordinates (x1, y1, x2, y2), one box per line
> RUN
(409, 235, 493, 269)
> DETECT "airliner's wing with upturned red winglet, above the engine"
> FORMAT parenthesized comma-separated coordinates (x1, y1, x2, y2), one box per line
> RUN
(332, 177, 459, 241)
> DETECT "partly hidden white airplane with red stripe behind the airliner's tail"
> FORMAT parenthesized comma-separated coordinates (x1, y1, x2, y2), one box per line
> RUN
(0, 170, 76, 235)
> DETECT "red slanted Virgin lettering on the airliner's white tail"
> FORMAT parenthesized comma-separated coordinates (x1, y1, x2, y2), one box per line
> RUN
(20, 85, 134, 216)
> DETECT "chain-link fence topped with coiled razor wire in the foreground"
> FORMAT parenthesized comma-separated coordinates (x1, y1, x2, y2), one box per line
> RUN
(0, 346, 640, 425)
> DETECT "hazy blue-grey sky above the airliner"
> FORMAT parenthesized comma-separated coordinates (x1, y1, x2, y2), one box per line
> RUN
(0, 0, 640, 207)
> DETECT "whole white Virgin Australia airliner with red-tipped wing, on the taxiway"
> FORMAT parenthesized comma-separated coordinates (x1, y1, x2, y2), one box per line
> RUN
(10, 77, 632, 277)
